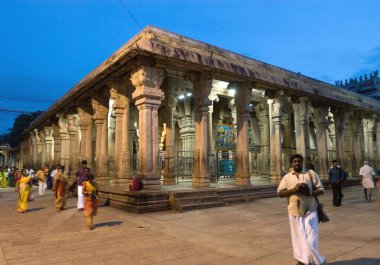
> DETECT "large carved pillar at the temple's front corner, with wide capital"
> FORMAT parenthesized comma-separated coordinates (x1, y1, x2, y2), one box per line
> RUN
(131, 65, 164, 190)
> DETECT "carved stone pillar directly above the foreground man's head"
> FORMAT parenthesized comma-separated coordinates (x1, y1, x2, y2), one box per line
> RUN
(293, 97, 310, 163)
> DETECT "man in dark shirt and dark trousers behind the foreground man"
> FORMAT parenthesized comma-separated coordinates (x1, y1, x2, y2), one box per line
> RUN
(327, 160, 345, 207)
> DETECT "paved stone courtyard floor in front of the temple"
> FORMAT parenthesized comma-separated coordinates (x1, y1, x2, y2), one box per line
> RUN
(0, 186, 380, 265)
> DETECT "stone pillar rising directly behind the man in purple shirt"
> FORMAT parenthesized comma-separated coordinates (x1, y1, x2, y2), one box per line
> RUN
(77, 104, 93, 168)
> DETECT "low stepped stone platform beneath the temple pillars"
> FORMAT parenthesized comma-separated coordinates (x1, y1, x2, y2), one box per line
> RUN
(99, 178, 360, 213)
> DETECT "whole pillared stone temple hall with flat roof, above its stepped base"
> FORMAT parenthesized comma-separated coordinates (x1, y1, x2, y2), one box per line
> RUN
(14, 26, 380, 210)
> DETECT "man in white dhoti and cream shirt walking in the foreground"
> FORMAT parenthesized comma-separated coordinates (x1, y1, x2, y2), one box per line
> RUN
(277, 154, 326, 265)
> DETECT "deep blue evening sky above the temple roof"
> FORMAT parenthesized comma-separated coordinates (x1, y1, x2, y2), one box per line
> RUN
(0, 0, 380, 133)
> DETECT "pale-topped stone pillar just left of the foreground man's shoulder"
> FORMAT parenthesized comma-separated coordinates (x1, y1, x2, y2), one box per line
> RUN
(268, 95, 284, 183)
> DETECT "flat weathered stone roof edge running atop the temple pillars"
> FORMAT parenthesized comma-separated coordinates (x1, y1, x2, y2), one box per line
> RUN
(23, 26, 380, 134)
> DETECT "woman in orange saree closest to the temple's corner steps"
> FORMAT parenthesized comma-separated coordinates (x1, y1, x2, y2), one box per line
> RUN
(82, 173, 99, 230)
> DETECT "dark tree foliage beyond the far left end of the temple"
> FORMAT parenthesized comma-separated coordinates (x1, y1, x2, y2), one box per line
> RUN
(0, 111, 42, 148)
